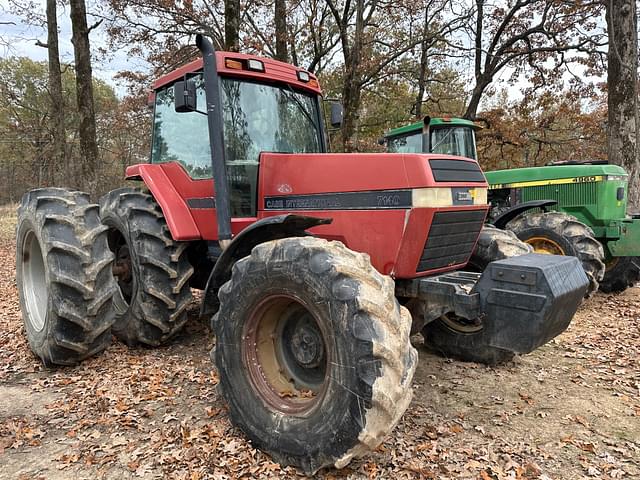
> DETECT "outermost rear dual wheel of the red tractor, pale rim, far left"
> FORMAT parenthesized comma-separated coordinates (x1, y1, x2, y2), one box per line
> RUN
(16, 188, 116, 366)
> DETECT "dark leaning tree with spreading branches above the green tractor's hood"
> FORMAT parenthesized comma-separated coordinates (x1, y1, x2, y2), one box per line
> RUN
(464, 0, 605, 119)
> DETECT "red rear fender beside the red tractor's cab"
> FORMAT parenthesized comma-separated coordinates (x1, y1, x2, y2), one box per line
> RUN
(125, 163, 202, 241)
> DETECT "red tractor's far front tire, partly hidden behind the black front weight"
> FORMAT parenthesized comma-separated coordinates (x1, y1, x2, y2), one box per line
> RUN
(420, 225, 533, 365)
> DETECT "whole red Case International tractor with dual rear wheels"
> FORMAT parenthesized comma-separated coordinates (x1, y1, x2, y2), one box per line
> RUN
(17, 36, 587, 472)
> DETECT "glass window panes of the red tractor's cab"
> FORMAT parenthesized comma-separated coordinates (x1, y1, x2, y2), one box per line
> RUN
(151, 75, 324, 217)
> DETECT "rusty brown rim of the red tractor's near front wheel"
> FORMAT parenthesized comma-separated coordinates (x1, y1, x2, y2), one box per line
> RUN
(242, 295, 329, 413)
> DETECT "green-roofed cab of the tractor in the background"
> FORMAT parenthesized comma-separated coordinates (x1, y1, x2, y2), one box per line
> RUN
(381, 116, 480, 160)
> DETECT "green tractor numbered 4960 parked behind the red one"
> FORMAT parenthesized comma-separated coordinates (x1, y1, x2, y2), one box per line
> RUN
(383, 117, 640, 296)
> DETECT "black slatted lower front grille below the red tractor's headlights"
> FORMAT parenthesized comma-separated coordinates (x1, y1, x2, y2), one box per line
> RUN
(416, 210, 486, 272)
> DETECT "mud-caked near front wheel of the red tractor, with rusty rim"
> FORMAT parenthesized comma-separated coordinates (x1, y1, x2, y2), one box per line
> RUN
(212, 237, 417, 474)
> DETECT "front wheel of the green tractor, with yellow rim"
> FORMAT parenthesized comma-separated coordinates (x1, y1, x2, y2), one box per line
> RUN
(507, 212, 605, 298)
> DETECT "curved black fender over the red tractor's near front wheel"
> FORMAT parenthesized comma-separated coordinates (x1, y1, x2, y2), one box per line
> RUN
(200, 214, 332, 317)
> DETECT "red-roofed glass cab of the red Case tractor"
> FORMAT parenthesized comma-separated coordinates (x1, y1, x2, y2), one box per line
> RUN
(151, 52, 326, 218)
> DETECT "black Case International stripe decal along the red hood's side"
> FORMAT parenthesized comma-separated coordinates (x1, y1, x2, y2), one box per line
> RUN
(264, 190, 411, 210)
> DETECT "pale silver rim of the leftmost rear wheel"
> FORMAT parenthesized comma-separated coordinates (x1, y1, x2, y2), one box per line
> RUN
(22, 231, 49, 332)
